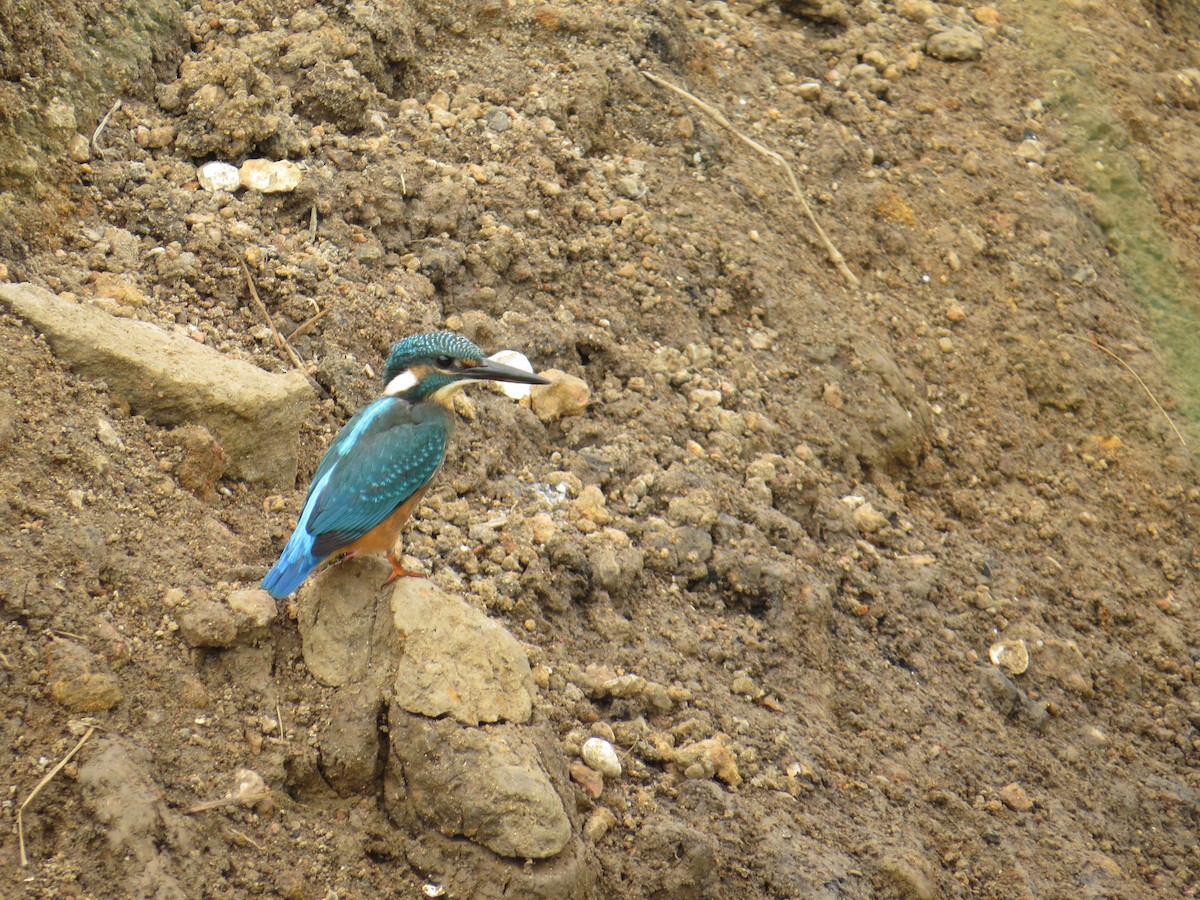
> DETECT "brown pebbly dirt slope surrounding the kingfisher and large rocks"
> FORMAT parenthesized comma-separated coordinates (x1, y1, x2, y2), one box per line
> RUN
(0, 0, 1200, 900)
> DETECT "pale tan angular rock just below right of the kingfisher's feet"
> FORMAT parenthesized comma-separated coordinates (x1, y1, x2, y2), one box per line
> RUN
(391, 578, 535, 725)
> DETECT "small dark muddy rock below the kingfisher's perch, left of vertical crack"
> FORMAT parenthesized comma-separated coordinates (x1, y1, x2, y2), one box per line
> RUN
(318, 684, 383, 797)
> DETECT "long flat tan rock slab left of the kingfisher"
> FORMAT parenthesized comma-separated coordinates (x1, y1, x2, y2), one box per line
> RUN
(0, 284, 314, 487)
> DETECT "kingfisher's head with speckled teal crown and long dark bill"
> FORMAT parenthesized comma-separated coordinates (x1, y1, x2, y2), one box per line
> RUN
(383, 331, 550, 406)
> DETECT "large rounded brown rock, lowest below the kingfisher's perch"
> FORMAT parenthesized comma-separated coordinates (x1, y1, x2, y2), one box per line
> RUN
(389, 704, 572, 859)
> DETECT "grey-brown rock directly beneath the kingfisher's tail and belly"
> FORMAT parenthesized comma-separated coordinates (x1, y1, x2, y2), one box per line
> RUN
(296, 557, 396, 688)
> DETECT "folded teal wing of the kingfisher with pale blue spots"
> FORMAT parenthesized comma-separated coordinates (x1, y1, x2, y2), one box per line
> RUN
(302, 397, 450, 556)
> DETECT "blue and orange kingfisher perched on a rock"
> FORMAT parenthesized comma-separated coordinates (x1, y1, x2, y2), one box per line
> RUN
(263, 331, 550, 600)
